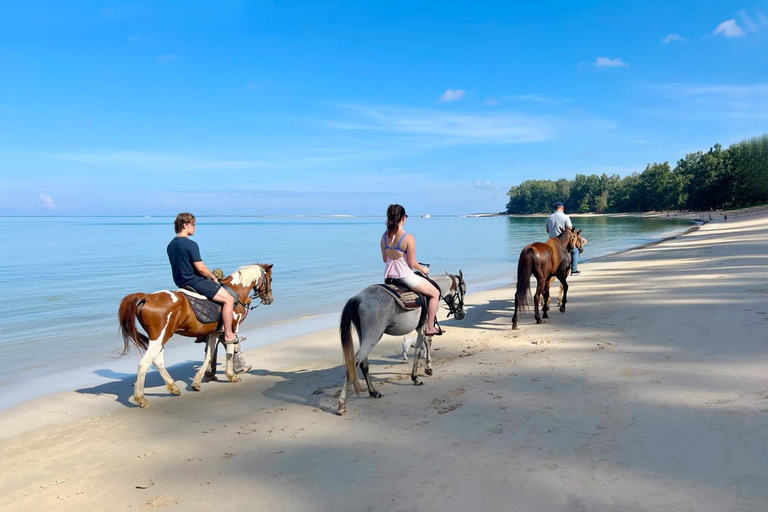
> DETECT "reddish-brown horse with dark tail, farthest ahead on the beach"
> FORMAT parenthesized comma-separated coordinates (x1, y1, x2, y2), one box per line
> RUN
(512, 228, 581, 329)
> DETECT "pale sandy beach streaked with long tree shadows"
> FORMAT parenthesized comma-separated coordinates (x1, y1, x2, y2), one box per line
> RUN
(0, 209, 768, 512)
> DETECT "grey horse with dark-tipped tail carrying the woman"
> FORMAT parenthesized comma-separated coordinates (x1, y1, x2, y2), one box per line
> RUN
(339, 270, 467, 414)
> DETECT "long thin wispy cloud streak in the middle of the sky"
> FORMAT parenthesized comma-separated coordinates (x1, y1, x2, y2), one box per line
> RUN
(326, 105, 613, 145)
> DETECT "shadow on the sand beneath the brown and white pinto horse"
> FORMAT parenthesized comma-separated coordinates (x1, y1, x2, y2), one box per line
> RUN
(75, 361, 206, 407)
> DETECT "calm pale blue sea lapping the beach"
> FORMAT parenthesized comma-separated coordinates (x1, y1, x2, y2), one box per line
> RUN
(0, 213, 689, 408)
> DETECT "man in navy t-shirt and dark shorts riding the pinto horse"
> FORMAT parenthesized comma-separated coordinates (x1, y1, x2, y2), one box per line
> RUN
(166, 213, 239, 343)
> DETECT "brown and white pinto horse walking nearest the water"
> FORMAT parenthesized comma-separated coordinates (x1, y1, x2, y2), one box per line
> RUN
(118, 264, 274, 407)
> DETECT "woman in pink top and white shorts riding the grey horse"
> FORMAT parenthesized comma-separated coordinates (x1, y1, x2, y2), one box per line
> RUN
(379, 204, 443, 336)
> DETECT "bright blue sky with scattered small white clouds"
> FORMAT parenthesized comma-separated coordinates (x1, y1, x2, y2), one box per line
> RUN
(0, 0, 768, 215)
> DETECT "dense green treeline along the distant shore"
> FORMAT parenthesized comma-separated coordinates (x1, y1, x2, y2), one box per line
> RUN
(507, 134, 768, 214)
